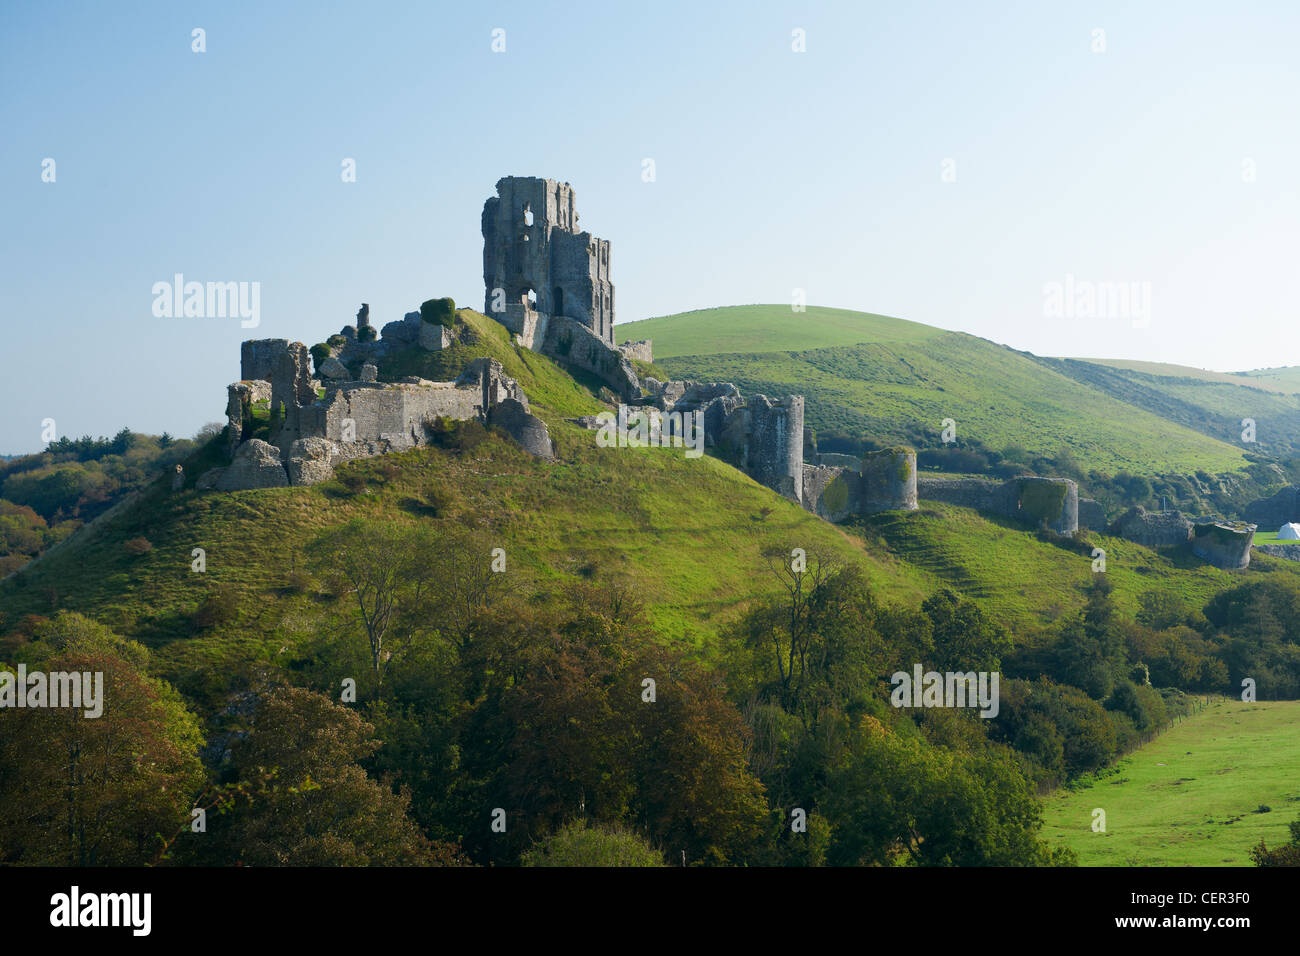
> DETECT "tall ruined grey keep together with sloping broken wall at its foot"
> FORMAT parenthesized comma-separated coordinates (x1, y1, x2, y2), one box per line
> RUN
(482, 176, 637, 402)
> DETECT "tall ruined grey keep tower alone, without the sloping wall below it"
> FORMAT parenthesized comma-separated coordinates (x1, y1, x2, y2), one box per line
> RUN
(482, 176, 614, 347)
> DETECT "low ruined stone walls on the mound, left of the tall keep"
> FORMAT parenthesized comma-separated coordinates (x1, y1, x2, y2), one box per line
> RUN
(195, 321, 554, 492)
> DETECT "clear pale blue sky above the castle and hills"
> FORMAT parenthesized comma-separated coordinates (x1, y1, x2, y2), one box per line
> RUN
(0, 0, 1300, 454)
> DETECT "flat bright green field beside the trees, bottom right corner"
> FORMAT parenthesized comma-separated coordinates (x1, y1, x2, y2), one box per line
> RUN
(1043, 700, 1300, 866)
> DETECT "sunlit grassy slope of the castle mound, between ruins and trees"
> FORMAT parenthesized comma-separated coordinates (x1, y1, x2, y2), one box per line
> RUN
(0, 314, 932, 679)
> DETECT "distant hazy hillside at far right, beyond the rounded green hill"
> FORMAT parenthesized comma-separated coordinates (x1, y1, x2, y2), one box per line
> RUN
(1037, 359, 1300, 457)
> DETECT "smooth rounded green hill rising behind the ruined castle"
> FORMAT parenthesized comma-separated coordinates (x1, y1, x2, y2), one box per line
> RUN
(629, 306, 1245, 475)
